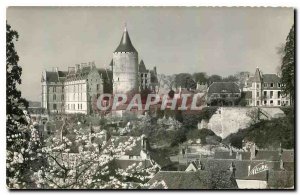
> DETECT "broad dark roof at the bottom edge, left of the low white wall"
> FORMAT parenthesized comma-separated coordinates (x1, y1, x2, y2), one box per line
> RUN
(147, 171, 209, 189)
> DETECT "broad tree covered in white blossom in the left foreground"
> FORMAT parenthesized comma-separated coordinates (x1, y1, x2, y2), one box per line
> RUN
(32, 127, 157, 189)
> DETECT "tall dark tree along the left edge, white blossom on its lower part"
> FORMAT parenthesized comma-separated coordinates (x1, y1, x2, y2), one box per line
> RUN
(6, 23, 39, 188)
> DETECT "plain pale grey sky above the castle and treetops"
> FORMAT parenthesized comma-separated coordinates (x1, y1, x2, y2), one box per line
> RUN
(7, 7, 294, 101)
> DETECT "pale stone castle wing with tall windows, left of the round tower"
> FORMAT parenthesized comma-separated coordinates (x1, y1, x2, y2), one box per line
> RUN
(42, 63, 104, 114)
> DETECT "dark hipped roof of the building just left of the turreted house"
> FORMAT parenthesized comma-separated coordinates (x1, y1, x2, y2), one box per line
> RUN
(208, 82, 240, 94)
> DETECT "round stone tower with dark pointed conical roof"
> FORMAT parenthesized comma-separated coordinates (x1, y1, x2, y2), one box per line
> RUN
(112, 26, 138, 94)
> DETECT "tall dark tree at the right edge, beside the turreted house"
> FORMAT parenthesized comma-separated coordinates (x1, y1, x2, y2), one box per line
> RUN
(281, 25, 295, 104)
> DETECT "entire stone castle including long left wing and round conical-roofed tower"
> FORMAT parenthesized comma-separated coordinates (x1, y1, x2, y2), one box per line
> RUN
(41, 27, 158, 114)
